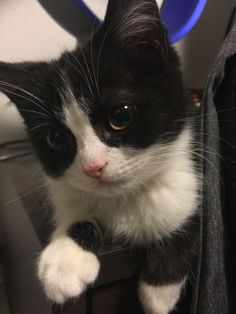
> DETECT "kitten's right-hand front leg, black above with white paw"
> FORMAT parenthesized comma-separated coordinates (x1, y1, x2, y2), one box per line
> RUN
(139, 217, 199, 314)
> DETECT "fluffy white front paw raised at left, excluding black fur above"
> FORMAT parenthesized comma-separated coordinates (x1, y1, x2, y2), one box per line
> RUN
(38, 238, 100, 303)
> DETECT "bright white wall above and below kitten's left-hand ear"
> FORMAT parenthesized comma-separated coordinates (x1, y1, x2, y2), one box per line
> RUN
(0, 0, 76, 142)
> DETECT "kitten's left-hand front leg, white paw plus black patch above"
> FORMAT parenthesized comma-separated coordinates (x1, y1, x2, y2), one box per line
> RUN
(38, 221, 103, 303)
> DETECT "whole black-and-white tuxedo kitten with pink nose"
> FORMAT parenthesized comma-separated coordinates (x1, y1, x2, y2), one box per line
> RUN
(0, 0, 200, 314)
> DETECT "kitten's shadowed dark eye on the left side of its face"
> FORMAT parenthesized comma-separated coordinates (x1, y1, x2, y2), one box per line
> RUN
(46, 127, 69, 151)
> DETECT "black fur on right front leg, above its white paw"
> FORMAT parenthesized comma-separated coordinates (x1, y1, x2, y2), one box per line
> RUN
(141, 215, 200, 286)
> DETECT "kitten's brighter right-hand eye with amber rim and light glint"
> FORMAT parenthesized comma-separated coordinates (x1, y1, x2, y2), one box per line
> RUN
(108, 105, 136, 131)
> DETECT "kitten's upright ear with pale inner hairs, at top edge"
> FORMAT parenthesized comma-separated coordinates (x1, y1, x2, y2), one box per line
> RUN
(104, 0, 170, 57)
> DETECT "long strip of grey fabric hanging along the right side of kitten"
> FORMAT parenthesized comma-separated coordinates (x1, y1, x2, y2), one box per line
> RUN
(191, 25, 236, 314)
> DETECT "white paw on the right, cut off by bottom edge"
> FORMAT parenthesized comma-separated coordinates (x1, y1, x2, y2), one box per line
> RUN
(139, 280, 184, 314)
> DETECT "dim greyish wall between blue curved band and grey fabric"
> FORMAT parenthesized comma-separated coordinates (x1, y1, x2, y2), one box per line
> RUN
(178, 0, 236, 88)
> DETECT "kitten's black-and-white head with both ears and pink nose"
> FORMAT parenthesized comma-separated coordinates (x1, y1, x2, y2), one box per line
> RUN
(0, 0, 193, 195)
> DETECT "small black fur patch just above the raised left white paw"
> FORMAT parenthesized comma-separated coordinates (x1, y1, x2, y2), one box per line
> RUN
(67, 220, 103, 254)
